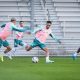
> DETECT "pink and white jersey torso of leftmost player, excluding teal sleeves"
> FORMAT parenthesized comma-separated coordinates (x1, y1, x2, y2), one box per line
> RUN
(0, 22, 12, 40)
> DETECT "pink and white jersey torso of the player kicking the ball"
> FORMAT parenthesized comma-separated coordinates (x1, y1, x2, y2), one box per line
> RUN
(35, 28, 52, 43)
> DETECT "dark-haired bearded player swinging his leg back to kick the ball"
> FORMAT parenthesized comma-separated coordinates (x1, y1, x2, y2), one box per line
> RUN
(26, 21, 61, 63)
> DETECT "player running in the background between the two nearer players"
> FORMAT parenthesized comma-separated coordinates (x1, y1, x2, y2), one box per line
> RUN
(14, 21, 30, 49)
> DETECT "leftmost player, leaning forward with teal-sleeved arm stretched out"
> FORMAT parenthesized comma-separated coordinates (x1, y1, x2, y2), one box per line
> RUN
(0, 18, 26, 58)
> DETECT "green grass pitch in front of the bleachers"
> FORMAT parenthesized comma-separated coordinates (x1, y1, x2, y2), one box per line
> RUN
(0, 57, 80, 80)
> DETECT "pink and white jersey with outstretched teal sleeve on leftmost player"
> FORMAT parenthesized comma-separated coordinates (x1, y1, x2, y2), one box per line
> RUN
(0, 22, 26, 40)
